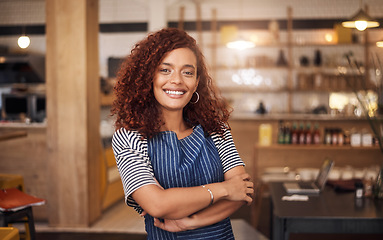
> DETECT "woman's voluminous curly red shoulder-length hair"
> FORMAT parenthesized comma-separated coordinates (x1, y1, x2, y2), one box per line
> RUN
(112, 28, 230, 138)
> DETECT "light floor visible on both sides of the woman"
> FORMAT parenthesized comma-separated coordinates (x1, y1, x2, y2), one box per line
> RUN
(36, 202, 267, 240)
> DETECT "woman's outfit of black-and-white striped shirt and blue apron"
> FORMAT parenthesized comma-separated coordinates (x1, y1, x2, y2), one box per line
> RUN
(112, 125, 244, 239)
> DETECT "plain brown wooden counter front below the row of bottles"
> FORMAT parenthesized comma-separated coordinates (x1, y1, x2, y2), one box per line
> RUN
(252, 144, 381, 179)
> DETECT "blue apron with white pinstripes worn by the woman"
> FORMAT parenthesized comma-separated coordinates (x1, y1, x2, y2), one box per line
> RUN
(145, 125, 234, 240)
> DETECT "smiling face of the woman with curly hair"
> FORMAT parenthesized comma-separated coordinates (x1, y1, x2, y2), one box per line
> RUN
(153, 48, 198, 114)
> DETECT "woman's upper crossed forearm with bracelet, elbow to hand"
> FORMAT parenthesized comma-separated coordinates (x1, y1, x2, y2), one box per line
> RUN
(132, 174, 253, 219)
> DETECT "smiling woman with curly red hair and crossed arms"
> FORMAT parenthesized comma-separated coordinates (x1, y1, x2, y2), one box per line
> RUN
(112, 29, 253, 240)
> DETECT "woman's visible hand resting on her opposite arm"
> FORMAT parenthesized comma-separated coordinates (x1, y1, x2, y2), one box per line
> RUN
(223, 173, 254, 205)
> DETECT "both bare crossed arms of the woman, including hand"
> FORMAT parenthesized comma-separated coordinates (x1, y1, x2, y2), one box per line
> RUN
(132, 166, 254, 232)
